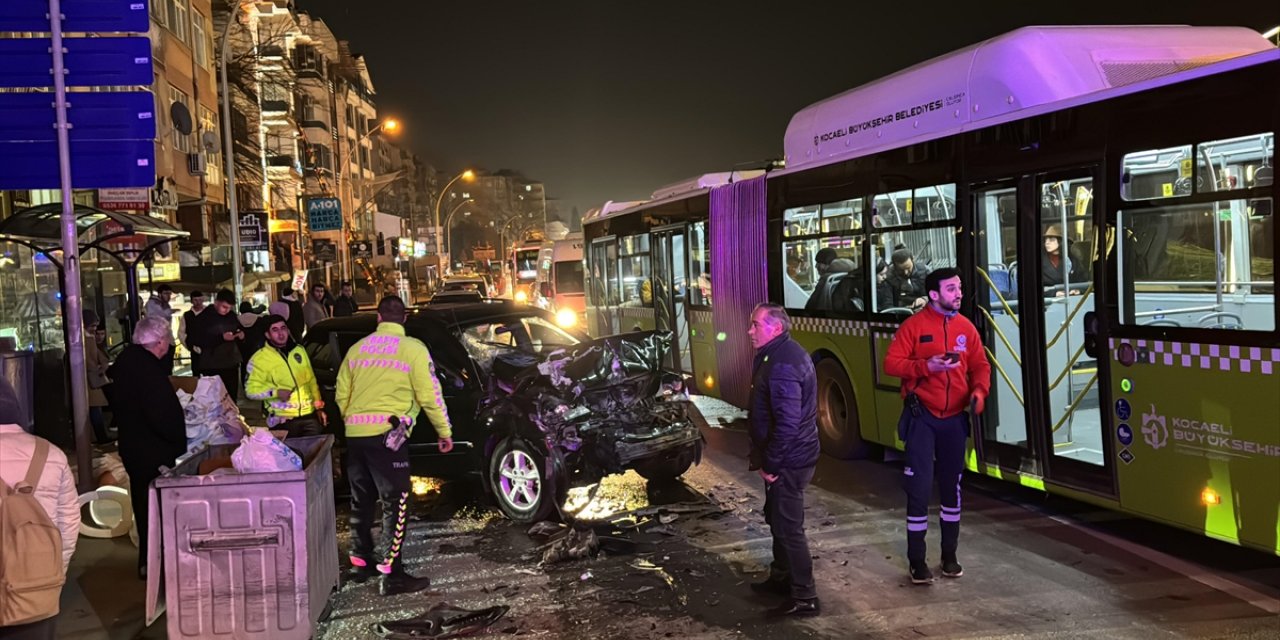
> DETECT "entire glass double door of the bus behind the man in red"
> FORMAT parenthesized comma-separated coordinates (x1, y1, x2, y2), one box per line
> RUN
(972, 169, 1114, 494)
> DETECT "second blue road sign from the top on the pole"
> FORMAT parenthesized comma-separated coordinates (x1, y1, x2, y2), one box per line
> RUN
(0, 37, 155, 88)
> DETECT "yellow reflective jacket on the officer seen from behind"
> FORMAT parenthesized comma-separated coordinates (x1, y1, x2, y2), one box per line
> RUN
(334, 323, 453, 438)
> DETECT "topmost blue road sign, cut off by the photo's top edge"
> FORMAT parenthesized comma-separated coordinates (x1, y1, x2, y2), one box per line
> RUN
(0, 0, 151, 33)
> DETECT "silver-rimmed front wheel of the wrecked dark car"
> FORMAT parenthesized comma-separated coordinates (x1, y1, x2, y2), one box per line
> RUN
(489, 436, 559, 524)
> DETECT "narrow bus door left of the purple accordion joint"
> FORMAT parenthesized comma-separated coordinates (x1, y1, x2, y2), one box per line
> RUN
(652, 225, 694, 375)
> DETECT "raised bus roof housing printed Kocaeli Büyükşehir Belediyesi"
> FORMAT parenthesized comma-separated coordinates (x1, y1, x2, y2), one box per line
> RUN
(778, 26, 1276, 173)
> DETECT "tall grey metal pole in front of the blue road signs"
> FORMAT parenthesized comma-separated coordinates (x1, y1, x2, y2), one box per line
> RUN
(49, 0, 93, 493)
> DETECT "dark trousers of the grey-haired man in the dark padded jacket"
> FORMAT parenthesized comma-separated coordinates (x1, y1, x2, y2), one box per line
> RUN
(764, 467, 818, 599)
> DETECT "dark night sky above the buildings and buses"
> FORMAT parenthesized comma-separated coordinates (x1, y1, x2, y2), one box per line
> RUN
(297, 0, 1280, 212)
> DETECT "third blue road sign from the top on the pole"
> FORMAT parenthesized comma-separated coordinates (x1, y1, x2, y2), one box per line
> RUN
(0, 91, 156, 142)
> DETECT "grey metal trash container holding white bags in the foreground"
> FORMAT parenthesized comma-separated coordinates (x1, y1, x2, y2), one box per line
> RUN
(147, 435, 338, 640)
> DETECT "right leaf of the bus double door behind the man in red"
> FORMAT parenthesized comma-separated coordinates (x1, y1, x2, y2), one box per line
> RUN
(1018, 169, 1115, 488)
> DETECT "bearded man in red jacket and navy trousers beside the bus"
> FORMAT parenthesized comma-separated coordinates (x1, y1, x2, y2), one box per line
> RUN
(884, 268, 991, 585)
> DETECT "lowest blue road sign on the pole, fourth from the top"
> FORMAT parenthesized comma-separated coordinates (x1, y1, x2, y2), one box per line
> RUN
(0, 140, 156, 189)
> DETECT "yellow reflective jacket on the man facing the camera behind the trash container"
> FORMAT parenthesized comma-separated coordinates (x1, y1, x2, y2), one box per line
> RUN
(244, 344, 324, 428)
